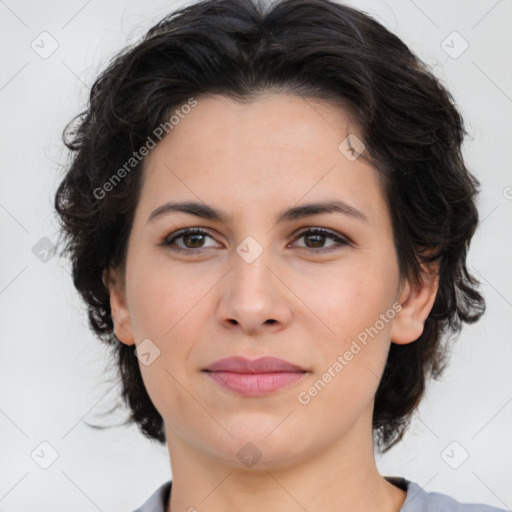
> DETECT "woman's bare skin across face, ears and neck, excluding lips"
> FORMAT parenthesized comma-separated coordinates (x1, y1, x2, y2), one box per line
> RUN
(107, 93, 437, 512)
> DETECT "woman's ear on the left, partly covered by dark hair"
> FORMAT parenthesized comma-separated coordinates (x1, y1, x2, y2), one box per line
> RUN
(103, 268, 135, 345)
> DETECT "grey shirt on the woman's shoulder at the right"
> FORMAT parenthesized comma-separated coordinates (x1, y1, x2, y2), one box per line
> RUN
(386, 477, 506, 512)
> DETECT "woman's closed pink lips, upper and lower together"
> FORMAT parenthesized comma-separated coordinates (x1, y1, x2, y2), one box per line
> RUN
(203, 356, 309, 396)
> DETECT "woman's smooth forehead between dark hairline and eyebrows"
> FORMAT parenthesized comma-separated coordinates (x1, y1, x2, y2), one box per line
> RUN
(136, 93, 388, 228)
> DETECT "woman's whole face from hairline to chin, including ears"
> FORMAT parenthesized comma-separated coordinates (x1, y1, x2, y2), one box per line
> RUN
(111, 94, 431, 468)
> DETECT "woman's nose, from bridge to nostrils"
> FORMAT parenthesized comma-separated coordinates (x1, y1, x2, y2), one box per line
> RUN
(217, 251, 293, 336)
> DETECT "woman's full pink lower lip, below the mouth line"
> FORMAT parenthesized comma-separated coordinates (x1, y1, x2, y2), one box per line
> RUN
(206, 372, 307, 396)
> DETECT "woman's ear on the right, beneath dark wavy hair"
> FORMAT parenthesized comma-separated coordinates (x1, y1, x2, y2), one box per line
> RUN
(391, 264, 439, 345)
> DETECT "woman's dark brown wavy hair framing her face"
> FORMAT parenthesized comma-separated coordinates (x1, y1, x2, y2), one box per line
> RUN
(55, 0, 485, 452)
